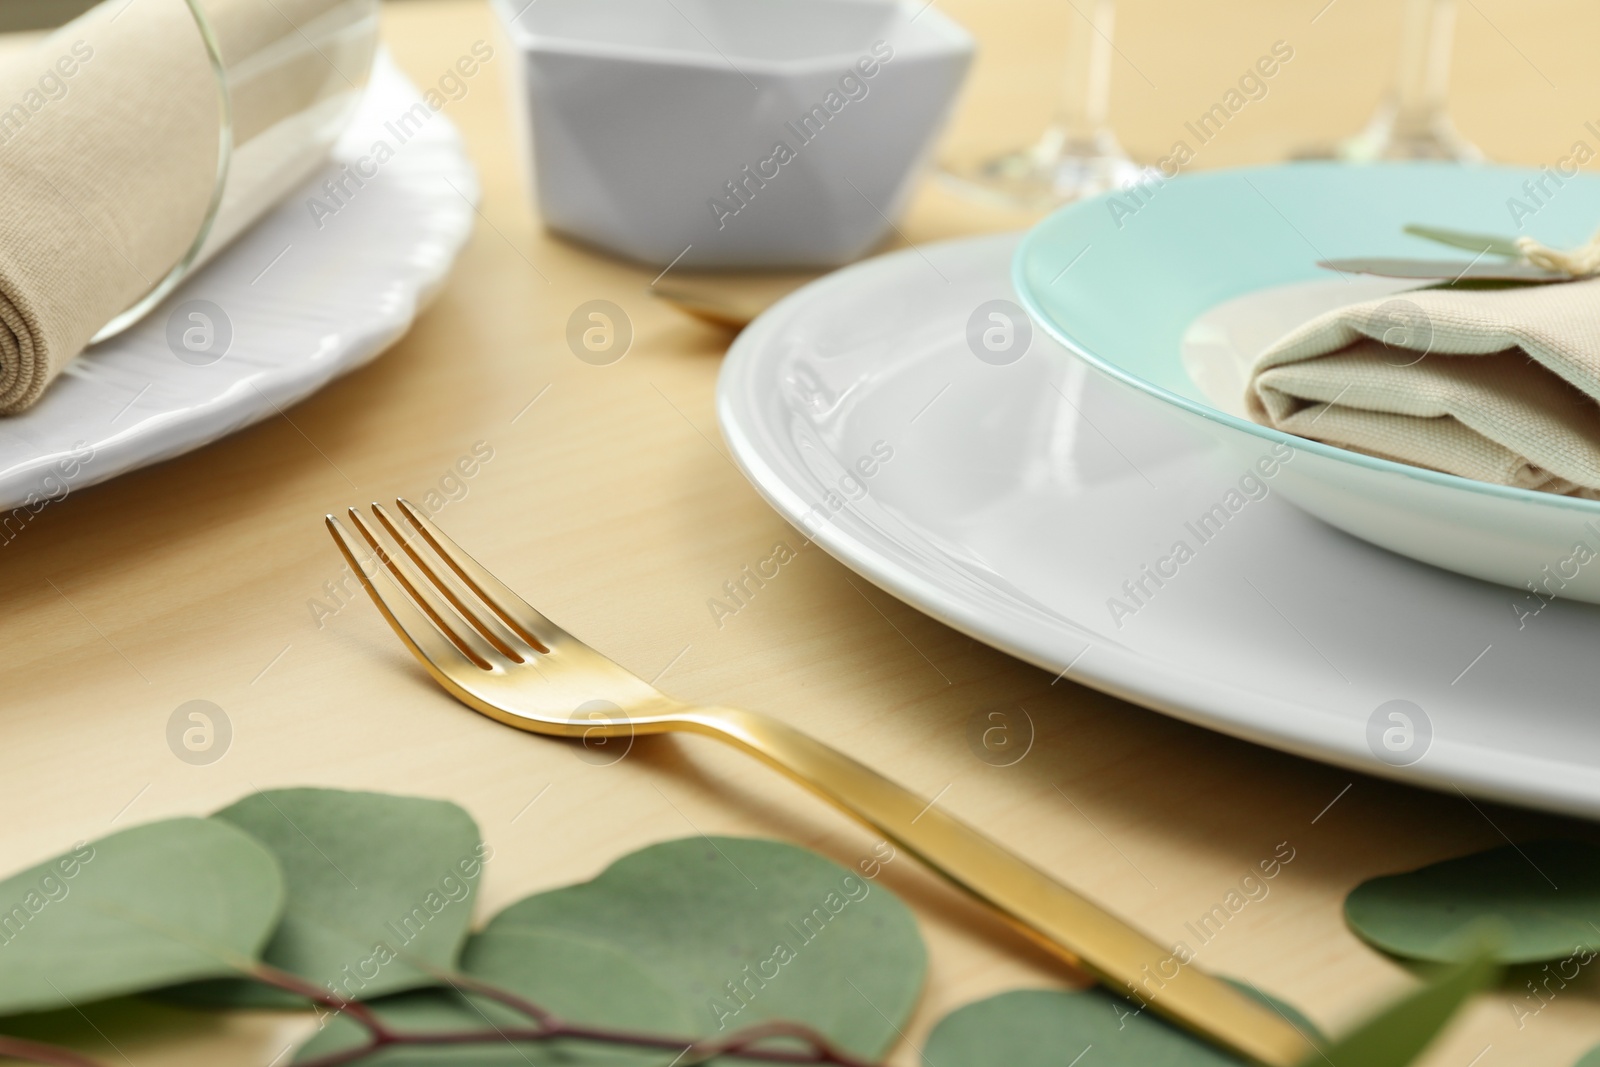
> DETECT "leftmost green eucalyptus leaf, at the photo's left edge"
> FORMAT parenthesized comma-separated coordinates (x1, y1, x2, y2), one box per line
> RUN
(0, 819, 285, 1014)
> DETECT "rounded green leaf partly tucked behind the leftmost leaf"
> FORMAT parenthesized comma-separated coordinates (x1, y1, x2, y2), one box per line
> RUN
(174, 789, 486, 1006)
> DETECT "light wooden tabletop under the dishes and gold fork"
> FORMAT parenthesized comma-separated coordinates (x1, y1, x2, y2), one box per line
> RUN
(0, 0, 1600, 1067)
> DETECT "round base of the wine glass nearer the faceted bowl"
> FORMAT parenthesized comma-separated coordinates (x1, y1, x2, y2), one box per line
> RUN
(941, 149, 1158, 211)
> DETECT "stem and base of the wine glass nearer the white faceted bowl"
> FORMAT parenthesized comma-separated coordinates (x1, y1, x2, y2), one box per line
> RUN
(946, 0, 1146, 210)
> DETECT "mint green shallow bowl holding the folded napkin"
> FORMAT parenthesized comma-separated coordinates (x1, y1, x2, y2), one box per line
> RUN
(1011, 163, 1600, 604)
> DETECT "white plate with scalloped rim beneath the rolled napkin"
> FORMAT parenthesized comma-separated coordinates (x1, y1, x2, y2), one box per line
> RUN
(0, 53, 478, 515)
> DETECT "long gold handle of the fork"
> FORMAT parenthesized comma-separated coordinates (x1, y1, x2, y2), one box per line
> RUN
(683, 707, 1314, 1067)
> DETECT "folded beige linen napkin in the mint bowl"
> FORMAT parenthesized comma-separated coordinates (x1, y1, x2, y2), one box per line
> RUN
(1246, 278, 1600, 499)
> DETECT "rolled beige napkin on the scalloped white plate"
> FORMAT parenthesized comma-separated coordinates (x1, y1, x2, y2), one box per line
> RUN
(0, 0, 371, 414)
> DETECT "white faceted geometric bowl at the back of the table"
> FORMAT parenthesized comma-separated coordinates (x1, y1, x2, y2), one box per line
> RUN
(493, 0, 973, 267)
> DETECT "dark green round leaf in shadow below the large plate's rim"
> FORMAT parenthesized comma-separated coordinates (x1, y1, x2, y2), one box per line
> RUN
(1344, 841, 1600, 963)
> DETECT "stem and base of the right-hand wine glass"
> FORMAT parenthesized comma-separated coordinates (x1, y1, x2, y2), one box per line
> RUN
(1301, 0, 1483, 163)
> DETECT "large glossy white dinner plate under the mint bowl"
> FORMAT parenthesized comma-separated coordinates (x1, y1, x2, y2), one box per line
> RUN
(718, 235, 1600, 816)
